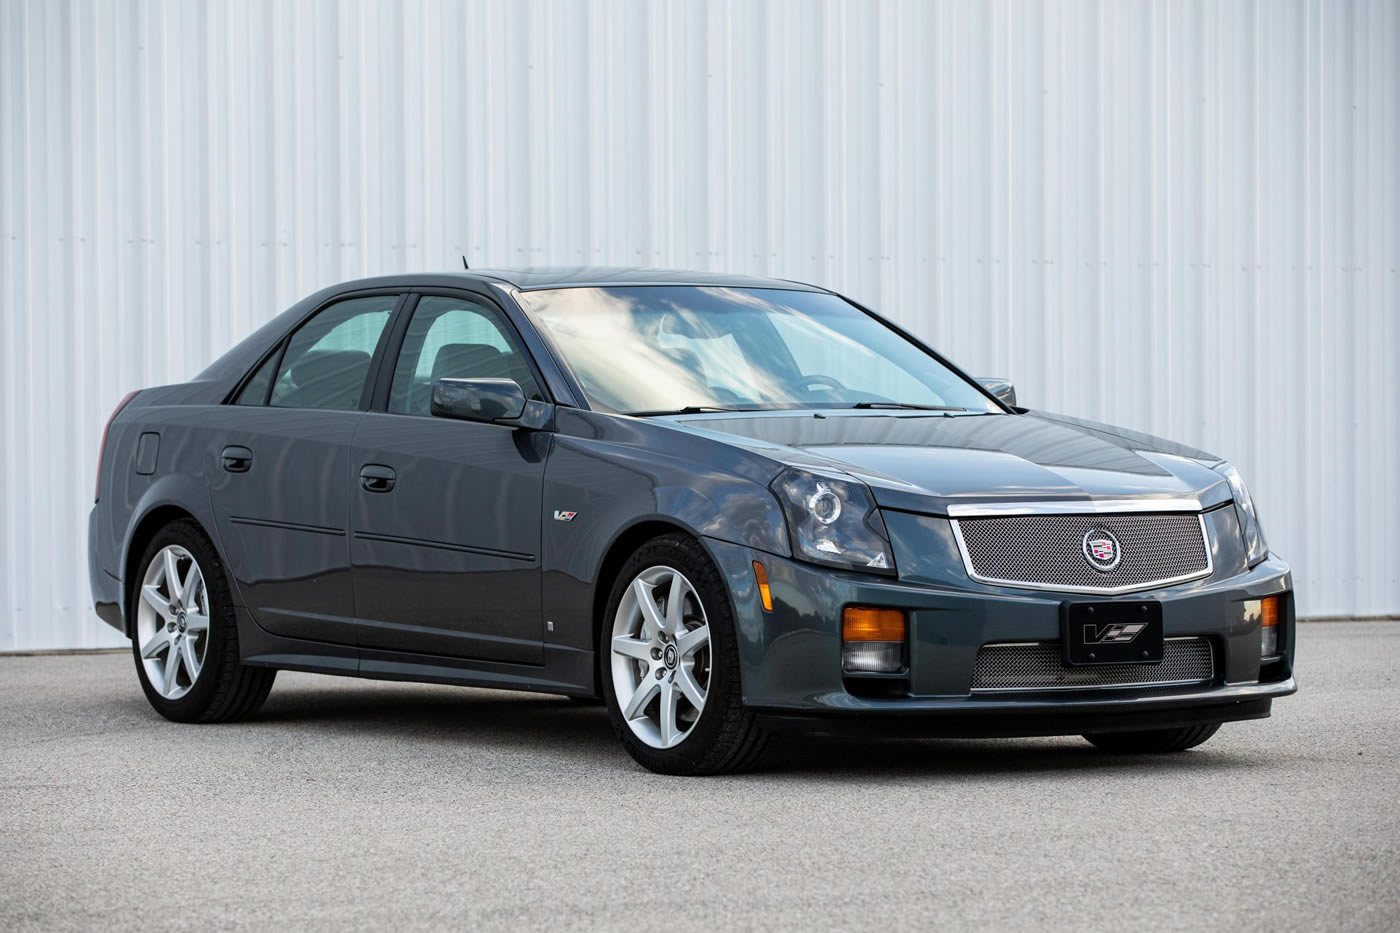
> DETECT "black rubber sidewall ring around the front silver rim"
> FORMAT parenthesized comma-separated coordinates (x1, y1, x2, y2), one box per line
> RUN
(598, 526, 742, 775)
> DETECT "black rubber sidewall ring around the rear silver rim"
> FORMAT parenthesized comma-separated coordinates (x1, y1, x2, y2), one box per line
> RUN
(127, 520, 239, 723)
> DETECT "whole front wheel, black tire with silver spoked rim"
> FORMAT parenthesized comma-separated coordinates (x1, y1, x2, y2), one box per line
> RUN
(598, 534, 767, 775)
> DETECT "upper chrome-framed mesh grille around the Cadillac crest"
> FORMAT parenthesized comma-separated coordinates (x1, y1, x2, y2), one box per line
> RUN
(956, 513, 1210, 591)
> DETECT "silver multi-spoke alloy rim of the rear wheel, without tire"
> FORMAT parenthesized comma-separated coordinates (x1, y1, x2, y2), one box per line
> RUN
(136, 545, 209, 700)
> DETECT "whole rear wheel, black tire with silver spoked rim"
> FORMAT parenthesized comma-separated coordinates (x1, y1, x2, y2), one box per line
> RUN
(127, 518, 277, 723)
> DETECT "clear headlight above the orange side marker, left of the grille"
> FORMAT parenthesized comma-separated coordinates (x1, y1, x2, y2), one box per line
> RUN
(773, 467, 895, 573)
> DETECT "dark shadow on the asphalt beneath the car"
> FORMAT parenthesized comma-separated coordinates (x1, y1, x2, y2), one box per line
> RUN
(224, 684, 1253, 782)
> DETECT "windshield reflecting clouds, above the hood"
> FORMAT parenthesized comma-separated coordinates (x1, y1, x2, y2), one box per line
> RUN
(519, 286, 1001, 415)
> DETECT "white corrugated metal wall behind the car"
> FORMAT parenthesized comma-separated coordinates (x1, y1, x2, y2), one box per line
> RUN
(0, 0, 1400, 650)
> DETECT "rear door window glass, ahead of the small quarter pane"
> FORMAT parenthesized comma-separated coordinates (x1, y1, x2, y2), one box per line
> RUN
(264, 296, 398, 412)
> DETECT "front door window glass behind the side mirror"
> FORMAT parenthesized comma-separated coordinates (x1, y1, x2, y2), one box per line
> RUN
(389, 296, 542, 415)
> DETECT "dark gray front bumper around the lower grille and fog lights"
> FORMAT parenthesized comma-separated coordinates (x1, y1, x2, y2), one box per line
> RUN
(707, 523, 1296, 735)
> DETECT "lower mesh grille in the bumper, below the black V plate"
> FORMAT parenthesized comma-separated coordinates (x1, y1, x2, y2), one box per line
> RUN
(972, 636, 1215, 692)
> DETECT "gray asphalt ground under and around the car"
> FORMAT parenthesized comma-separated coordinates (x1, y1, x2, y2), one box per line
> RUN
(0, 622, 1400, 932)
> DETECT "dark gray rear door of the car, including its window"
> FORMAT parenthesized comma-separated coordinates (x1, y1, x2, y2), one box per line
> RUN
(206, 294, 400, 644)
